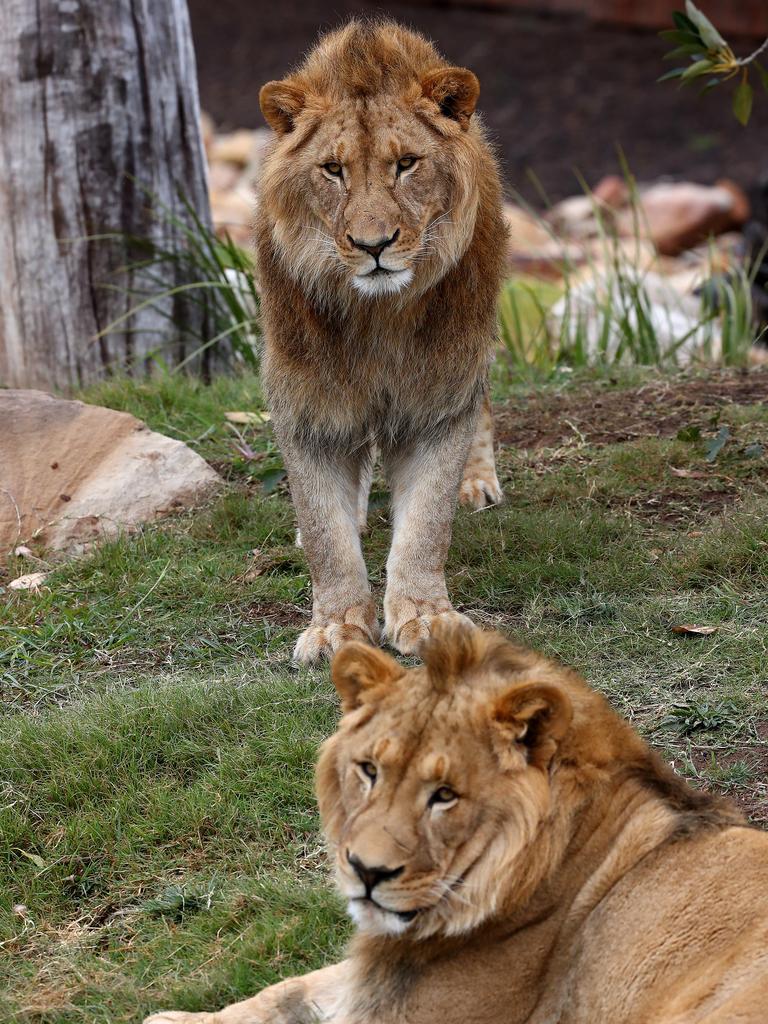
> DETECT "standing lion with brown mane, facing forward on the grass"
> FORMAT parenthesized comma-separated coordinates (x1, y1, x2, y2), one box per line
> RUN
(249, 22, 506, 662)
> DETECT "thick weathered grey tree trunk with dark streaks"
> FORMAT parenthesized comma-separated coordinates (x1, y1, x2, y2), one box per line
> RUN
(0, 0, 209, 391)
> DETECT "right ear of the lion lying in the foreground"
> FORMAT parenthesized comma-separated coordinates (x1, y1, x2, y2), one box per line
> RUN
(492, 682, 573, 768)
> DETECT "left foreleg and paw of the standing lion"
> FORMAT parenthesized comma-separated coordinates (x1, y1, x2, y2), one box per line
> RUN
(283, 444, 379, 662)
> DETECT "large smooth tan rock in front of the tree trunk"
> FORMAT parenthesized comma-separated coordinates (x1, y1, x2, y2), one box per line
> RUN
(0, 390, 221, 557)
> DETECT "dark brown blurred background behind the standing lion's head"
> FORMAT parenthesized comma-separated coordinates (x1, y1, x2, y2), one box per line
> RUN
(189, 0, 768, 199)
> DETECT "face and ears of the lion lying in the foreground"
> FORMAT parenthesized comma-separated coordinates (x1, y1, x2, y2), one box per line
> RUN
(317, 627, 570, 937)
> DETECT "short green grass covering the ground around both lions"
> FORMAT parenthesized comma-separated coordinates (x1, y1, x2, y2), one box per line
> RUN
(0, 371, 768, 1024)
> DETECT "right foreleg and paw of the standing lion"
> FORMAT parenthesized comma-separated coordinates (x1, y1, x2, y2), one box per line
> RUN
(384, 415, 475, 654)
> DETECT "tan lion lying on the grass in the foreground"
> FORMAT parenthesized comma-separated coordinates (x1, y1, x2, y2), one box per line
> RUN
(146, 622, 768, 1024)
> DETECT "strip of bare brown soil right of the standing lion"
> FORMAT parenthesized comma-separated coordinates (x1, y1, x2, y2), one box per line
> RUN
(495, 368, 768, 449)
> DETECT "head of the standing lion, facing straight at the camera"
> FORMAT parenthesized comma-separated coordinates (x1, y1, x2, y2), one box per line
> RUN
(259, 25, 487, 296)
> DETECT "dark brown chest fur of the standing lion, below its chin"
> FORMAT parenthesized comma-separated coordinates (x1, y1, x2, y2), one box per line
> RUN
(263, 237, 495, 444)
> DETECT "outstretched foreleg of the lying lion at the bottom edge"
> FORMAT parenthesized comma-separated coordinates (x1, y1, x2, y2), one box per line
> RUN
(144, 961, 351, 1024)
